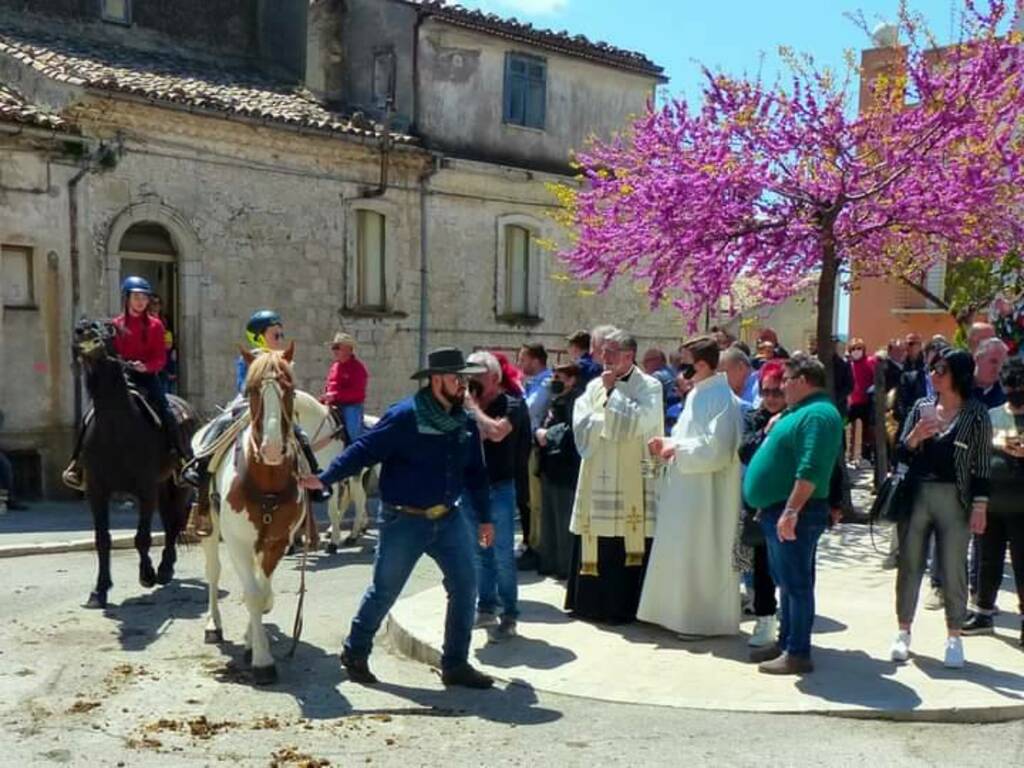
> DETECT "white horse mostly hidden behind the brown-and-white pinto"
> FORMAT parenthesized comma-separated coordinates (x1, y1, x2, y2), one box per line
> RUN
(295, 390, 377, 554)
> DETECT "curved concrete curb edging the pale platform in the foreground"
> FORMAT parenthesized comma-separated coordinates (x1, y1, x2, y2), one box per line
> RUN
(385, 613, 1024, 724)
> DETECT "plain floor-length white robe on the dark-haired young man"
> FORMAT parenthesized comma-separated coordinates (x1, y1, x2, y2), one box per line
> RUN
(637, 374, 742, 636)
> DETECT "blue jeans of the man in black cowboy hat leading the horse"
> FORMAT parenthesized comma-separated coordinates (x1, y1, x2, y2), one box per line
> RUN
(345, 503, 476, 670)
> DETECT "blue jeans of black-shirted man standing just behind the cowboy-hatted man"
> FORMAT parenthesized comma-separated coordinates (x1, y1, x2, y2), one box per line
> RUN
(462, 480, 519, 618)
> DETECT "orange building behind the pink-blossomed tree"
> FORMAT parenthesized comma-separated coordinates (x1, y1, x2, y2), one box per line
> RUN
(850, 33, 956, 350)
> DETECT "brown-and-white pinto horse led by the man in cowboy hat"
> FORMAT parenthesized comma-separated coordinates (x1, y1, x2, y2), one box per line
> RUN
(203, 343, 307, 684)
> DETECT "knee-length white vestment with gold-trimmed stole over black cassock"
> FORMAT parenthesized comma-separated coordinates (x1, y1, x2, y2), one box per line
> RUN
(569, 367, 665, 575)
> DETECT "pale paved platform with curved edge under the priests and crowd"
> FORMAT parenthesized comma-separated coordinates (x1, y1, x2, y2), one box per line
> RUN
(388, 525, 1024, 722)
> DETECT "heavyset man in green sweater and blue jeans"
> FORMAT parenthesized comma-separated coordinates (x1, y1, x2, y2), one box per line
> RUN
(743, 353, 843, 675)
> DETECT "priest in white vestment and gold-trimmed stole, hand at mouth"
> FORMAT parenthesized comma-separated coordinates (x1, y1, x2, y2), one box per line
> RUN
(565, 331, 665, 624)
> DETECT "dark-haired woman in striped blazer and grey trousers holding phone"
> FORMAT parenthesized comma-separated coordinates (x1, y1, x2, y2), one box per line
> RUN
(891, 348, 992, 669)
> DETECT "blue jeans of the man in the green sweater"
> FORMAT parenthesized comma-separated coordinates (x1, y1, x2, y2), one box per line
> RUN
(760, 499, 828, 656)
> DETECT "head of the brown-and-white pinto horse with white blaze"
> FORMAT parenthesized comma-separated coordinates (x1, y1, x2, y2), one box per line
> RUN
(242, 342, 295, 466)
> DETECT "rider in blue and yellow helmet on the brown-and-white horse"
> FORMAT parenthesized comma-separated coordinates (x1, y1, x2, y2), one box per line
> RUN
(184, 309, 331, 537)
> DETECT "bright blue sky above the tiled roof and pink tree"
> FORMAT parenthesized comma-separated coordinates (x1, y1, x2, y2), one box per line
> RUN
(462, 0, 962, 107)
